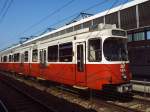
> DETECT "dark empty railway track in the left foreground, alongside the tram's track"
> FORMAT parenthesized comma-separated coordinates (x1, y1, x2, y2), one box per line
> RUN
(0, 72, 96, 112)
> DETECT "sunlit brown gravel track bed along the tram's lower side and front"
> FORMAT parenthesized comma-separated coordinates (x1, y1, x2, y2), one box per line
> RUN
(1, 71, 150, 112)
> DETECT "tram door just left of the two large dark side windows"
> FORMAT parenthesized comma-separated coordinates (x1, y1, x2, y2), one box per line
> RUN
(40, 49, 46, 78)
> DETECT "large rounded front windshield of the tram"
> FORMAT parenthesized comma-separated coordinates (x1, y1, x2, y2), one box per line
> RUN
(103, 37, 128, 61)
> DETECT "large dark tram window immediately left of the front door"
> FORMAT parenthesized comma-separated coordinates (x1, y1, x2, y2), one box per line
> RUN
(59, 42, 73, 62)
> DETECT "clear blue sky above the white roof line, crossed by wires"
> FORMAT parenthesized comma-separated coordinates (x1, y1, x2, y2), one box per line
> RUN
(0, 0, 130, 49)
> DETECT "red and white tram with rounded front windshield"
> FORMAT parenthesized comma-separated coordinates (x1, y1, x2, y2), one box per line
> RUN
(0, 24, 132, 92)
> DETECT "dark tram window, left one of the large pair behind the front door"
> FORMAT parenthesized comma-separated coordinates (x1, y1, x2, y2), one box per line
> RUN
(48, 45, 58, 62)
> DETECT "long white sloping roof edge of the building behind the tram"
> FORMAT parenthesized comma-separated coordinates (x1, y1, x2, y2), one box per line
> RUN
(1, 0, 149, 52)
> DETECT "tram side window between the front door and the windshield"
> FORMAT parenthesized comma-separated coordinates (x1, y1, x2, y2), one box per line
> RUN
(88, 38, 102, 62)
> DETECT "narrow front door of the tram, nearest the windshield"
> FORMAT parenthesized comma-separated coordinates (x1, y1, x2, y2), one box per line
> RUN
(75, 42, 86, 86)
